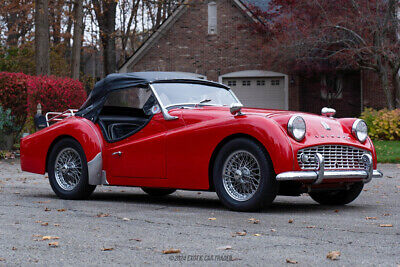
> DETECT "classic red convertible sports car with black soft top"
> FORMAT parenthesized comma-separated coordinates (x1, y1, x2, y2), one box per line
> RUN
(21, 72, 382, 211)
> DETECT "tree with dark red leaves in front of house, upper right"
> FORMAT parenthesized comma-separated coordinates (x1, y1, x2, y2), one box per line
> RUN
(252, 0, 400, 109)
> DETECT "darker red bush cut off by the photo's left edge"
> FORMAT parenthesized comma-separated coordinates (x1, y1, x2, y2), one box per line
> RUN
(0, 72, 29, 127)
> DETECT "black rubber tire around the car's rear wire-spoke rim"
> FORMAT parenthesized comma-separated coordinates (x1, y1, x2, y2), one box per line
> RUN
(48, 138, 96, 199)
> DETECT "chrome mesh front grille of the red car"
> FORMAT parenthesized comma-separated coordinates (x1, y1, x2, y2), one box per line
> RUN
(297, 145, 371, 170)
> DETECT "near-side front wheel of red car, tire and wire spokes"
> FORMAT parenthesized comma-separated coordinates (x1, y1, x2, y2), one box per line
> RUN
(213, 138, 277, 211)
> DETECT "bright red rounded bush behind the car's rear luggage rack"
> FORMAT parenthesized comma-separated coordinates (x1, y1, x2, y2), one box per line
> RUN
(27, 76, 86, 115)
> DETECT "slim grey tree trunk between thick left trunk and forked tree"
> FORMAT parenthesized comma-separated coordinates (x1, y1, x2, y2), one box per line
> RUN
(71, 0, 83, 80)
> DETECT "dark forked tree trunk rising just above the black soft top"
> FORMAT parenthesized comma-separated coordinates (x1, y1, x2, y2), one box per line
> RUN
(92, 0, 118, 75)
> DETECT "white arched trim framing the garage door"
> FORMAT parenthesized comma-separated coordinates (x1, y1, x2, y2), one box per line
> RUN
(218, 70, 289, 110)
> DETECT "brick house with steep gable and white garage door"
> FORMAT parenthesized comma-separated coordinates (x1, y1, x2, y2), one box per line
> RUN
(119, 0, 385, 117)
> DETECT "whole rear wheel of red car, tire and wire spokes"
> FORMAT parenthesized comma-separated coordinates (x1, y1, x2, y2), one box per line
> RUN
(48, 138, 96, 199)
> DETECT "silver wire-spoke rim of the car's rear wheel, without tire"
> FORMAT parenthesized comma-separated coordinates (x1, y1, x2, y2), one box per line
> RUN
(54, 147, 82, 191)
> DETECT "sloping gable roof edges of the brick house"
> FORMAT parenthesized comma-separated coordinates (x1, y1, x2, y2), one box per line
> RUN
(119, 0, 270, 72)
